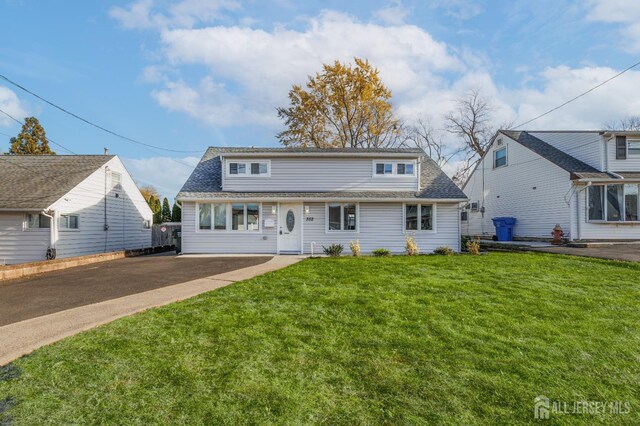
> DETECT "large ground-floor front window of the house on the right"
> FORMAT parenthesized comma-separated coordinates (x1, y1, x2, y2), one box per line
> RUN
(587, 183, 640, 222)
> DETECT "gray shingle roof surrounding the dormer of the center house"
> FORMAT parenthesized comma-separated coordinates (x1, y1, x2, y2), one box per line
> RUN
(177, 147, 467, 200)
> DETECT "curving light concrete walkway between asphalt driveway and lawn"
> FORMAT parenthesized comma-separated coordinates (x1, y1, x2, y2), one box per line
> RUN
(0, 256, 304, 366)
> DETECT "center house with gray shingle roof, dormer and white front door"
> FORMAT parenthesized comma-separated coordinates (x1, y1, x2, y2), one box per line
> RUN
(177, 148, 466, 254)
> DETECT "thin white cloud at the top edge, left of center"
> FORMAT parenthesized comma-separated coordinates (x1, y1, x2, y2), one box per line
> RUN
(109, 0, 240, 29)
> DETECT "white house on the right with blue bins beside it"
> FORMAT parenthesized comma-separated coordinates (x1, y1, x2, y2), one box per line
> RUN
(462, 130, 640, 240)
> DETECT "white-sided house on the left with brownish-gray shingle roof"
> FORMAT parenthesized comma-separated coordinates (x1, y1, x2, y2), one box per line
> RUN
(0, 155, 153, 265)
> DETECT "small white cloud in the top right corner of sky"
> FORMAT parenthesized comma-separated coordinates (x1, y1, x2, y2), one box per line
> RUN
(587, 0, 640, 52)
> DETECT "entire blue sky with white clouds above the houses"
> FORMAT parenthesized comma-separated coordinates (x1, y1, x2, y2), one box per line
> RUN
(0, 0, 640, 197)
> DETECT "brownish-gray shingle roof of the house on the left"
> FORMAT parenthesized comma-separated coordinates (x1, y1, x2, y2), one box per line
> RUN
(0, 155, 114, 210)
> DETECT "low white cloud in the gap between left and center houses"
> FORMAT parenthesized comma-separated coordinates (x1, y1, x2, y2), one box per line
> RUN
(122, 157, 200, 199)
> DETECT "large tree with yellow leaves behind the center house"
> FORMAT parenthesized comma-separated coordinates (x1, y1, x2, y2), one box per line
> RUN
(277, 58, 400, 148)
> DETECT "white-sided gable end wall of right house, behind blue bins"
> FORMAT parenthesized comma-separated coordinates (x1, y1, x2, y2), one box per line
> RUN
(462, 135, 571, 238)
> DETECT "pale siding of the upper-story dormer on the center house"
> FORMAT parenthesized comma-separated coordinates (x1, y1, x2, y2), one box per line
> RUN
(223, 157, 418, 192)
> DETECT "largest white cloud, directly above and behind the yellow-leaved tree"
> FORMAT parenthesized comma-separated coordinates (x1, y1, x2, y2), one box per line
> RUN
(153, 12, 464, 126)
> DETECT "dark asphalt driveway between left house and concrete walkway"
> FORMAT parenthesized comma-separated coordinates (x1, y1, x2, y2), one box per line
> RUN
(0, 254, 272, 327)
